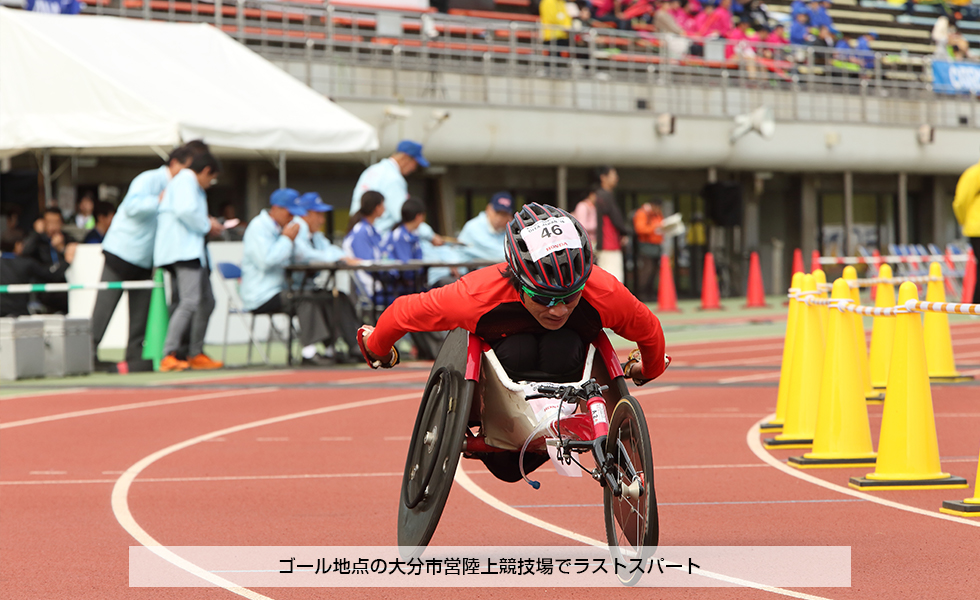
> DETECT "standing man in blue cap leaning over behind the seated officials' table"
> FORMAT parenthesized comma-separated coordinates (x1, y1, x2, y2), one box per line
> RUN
(350, 140, 442, 246)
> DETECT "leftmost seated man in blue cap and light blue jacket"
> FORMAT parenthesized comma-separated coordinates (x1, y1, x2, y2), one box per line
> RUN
(239, 188, 330, 365)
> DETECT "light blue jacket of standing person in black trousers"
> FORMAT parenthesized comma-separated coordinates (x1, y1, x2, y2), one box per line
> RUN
(102, 165, 170, 269)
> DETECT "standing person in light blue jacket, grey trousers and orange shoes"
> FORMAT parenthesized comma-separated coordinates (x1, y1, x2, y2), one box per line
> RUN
(153, 152, 224, 371)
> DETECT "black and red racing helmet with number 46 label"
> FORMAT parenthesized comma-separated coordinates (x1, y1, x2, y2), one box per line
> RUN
(504, 202, 593, 297)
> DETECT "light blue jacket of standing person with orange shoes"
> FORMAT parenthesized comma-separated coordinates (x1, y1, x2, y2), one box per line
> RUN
(153, 169, 211, 267)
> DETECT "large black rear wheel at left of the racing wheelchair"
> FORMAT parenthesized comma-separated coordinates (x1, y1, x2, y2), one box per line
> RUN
(398, 330, 475, 559)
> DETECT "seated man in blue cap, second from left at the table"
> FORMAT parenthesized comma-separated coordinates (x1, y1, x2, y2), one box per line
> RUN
(293, 192, 361, 362)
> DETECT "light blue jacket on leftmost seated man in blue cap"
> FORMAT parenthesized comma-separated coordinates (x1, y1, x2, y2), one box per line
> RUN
(239, 210, 299, 310)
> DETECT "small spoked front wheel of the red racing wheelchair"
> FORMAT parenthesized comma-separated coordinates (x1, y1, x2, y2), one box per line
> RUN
(603, 396, 660, 585)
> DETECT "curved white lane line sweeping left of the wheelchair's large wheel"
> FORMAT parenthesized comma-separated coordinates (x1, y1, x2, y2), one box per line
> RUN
(112, 393, 418, 600)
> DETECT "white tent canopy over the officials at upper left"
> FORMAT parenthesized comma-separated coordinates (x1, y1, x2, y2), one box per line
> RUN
(0, 7, 378, 157)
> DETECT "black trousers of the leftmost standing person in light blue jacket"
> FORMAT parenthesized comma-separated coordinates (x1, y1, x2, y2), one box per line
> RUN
(92, 252, 153, 362)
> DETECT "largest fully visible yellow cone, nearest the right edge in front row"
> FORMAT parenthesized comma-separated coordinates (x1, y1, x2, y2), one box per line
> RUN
(849, 281, 967, 490)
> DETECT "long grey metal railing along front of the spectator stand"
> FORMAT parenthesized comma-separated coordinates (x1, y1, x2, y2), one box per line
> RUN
(85, 0, 978, 127)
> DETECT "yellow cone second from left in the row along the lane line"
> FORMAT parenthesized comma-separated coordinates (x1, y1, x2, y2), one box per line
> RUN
(763, 275, 823, 448)
